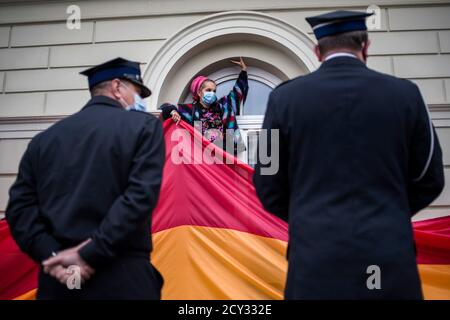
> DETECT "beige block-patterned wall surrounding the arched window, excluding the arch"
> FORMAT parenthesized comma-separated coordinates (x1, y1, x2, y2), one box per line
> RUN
(0, 0, 450, 218)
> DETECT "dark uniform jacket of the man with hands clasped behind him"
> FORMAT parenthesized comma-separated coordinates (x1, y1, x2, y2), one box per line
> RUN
(6, 96, 164, 268)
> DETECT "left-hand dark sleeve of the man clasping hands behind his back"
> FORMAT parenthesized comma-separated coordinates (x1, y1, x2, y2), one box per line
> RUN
(6, 141, 61, 263)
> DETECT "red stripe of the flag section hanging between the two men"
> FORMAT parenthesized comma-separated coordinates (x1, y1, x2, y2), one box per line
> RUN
(152, 119, 287, 241)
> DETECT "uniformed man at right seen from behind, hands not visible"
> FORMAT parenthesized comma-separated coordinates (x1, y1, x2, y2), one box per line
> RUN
(254, 11, 444, 299)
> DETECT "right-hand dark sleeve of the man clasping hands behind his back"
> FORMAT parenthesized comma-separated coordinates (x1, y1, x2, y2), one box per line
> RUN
(79, 119, 165, 268)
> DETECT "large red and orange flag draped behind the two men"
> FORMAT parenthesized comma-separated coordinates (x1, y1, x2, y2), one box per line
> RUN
(0, 120, 450, 299)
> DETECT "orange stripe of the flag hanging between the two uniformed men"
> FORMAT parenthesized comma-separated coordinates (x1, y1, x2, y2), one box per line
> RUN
(152, 226, 287, 300)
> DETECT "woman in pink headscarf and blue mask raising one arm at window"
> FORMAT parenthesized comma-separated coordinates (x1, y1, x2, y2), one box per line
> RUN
(160, 58, 248, 154)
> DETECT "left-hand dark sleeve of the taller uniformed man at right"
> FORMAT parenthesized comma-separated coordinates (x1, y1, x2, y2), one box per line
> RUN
(253, 93, 289, 221)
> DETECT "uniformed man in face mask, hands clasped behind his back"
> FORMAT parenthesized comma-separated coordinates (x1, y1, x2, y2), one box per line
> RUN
(6, 58, 164, 299)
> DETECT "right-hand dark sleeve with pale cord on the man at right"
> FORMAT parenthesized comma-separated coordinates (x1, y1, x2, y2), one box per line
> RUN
(408, 87, 444, 215)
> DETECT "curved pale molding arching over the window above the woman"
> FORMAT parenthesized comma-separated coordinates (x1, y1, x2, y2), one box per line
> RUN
(143, 11, 319, 111)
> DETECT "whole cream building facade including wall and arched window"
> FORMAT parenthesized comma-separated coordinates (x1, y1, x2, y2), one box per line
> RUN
(0, 0, 450, 219)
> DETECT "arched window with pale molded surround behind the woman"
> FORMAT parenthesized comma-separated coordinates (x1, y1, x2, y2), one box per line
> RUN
(144, 11, 320, 165)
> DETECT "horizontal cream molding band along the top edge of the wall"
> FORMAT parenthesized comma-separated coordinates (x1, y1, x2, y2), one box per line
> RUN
(0, 0, 448, 24)
